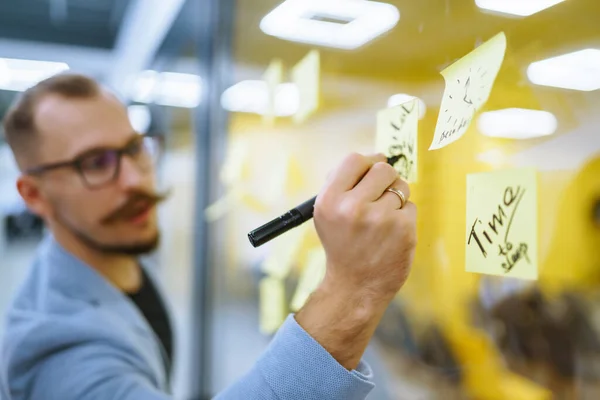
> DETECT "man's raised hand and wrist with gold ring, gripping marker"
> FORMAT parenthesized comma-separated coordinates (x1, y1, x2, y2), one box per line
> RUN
(296, 154, 417, 369)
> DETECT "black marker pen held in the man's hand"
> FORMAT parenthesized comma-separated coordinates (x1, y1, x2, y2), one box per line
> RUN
(248, 155, 402, 247)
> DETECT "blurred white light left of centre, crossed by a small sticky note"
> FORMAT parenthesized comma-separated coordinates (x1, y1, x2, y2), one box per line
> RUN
(221, 80, 300, 117)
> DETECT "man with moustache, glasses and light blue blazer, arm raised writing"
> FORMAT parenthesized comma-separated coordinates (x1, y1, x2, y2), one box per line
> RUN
(0, 74, 416, 400)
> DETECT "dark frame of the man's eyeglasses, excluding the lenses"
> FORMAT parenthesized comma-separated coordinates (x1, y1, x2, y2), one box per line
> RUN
(24, 133, 164, 189)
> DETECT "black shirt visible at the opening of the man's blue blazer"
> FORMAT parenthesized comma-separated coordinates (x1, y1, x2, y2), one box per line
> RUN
(129, 268, 173, 377)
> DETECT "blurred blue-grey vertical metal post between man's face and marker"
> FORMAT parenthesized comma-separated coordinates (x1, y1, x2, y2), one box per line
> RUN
(187, 0, 235, 400)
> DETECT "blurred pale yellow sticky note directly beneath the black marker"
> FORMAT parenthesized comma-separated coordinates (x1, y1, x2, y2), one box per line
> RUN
(261, 224, 310, 279)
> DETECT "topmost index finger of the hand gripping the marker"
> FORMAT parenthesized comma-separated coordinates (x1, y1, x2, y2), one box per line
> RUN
(326, 153, 386, 193)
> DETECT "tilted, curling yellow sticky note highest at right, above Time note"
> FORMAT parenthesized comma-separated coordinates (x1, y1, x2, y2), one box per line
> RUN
(429, 32, 506, 150)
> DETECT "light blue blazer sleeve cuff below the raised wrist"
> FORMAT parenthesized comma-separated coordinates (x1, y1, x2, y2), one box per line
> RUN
(216, 315, 374, 400)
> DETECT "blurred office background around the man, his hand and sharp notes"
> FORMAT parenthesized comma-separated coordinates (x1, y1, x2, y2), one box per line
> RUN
(0, 0, 600, 400)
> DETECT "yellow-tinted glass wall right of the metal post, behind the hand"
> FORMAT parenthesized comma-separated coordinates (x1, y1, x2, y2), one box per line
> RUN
(205, 0, 600, 399)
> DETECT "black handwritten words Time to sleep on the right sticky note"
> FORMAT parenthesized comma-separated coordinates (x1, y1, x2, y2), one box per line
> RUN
(467, 186, 529, 272)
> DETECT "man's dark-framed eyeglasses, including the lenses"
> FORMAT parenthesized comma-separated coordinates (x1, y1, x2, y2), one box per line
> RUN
(25, 135, 162, 189)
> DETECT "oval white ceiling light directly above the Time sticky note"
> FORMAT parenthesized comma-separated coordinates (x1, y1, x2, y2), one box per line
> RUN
(477, 108, 558, 139)
